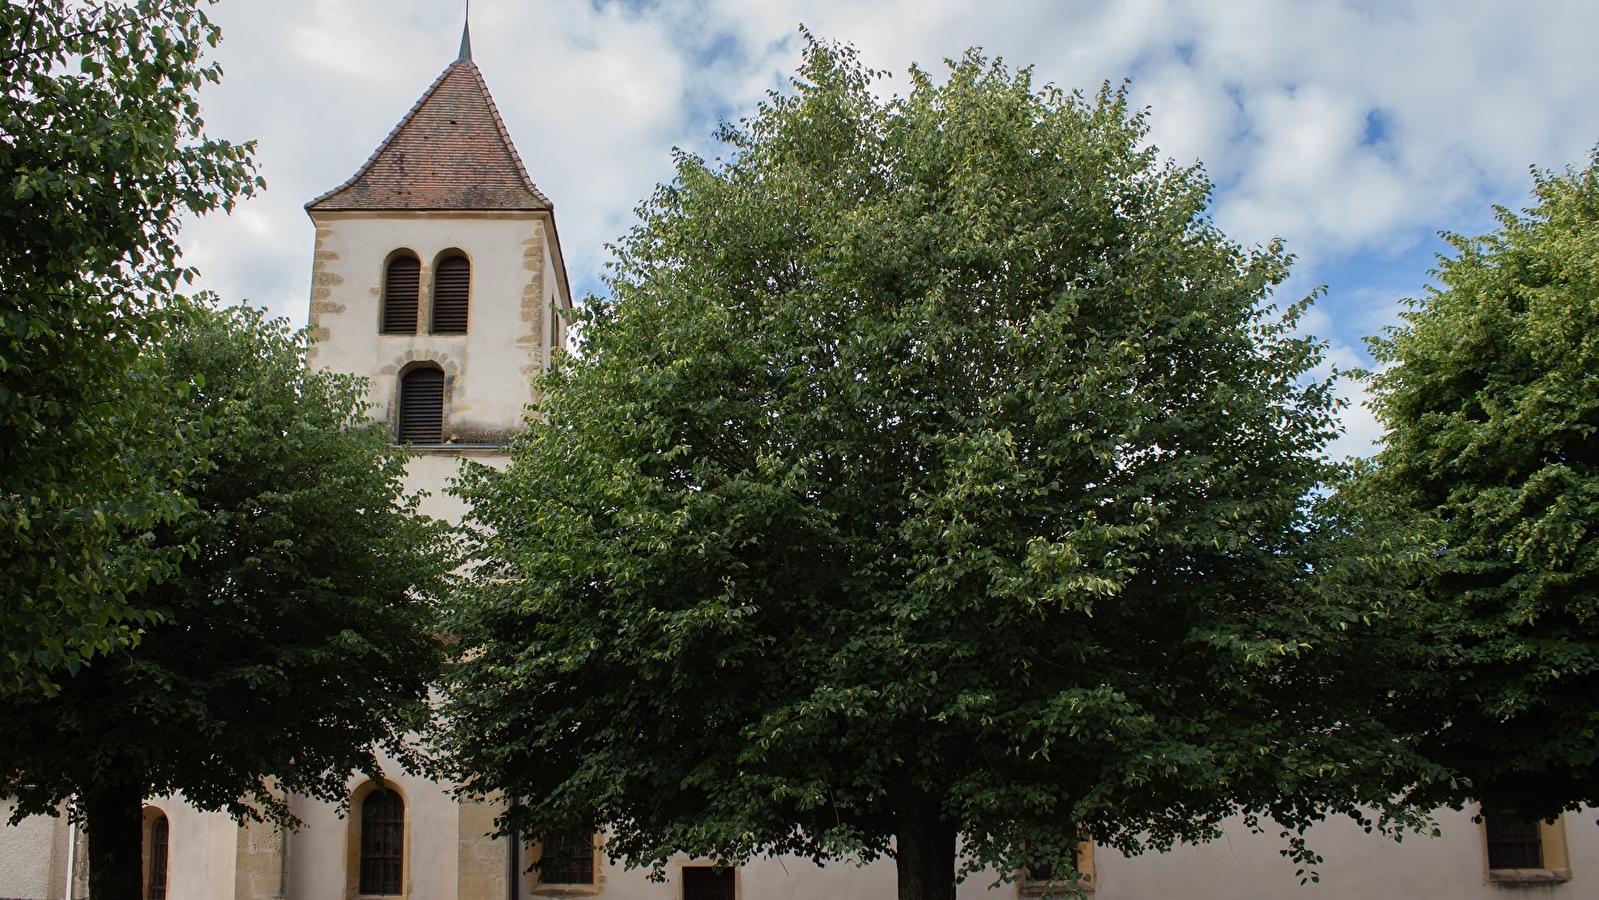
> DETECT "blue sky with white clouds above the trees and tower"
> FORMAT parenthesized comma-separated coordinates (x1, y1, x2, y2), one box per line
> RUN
(175, 0, 1599, 456)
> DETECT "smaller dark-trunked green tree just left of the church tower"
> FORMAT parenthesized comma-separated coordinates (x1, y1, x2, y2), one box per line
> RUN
(0, 309, 453, 900)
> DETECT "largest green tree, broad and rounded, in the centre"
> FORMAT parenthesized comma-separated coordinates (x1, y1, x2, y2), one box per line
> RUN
(440, 43, 1439, 900)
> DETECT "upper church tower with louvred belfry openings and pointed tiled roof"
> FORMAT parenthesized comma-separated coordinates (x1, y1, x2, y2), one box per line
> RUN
(305, 17, 571, 518)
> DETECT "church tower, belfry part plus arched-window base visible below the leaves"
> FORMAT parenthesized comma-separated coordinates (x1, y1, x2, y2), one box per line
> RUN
(271, 24, 571, 900)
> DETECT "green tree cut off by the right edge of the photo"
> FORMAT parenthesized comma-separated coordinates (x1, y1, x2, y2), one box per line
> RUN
(1350, 157, 1599, 817)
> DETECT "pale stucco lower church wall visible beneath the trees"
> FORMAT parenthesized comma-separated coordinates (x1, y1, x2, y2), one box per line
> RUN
(12, 799, 1599, 900)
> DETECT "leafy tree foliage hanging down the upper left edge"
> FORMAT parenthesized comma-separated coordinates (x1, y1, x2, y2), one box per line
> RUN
(0, 0, 259, 697)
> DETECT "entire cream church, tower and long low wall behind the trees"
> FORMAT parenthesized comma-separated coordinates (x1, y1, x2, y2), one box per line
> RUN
(0, 15, 1599, 900)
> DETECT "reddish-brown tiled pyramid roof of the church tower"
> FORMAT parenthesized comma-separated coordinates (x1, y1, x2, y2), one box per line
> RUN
(305, 59, 552, 209)
